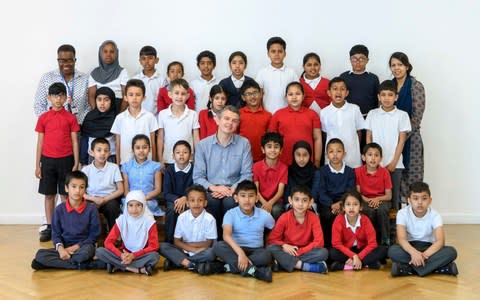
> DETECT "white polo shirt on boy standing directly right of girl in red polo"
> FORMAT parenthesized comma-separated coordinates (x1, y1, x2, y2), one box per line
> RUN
(320, 102, 365, 168)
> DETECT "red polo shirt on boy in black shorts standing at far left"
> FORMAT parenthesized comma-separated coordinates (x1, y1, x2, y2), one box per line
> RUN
(35, 108, 80, 158)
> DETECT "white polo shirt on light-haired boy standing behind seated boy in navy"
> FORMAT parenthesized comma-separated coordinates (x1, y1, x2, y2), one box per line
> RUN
(157, 104, 200, 163)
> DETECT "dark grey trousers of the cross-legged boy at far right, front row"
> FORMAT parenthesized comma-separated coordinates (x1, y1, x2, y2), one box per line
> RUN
(388, 241, 457, 276)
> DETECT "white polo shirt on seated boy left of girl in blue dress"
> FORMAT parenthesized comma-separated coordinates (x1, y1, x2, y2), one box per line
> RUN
(82, 161, 123, 197)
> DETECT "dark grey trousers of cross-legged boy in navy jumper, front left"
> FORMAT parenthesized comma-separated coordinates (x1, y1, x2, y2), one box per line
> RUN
(35, 244, 95, 270)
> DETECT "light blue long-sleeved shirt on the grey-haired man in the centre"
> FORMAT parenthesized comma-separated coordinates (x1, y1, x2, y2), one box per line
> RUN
(193, 134, 253, 189)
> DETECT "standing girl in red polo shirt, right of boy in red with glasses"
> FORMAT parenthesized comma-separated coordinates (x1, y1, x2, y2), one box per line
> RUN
(268, 81, 322, 168)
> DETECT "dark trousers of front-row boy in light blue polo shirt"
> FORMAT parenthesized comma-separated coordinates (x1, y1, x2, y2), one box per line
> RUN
(213, 241, 272, 273)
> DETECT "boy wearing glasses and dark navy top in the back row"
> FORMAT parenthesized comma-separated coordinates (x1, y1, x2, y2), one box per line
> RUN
(340, 45, 380, 149)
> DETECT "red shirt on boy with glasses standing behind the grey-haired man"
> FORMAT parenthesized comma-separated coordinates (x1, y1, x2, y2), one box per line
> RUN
(239, 106, 272, 162)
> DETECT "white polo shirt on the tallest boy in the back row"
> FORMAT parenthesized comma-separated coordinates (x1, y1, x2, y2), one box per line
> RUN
(255, 65, 299, 114)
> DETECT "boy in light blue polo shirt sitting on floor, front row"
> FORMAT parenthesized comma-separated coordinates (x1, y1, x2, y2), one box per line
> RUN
(213, 180, 275, 282)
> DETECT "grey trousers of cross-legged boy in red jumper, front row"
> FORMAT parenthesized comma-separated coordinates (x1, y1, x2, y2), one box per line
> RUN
(267, 245, 328, 272)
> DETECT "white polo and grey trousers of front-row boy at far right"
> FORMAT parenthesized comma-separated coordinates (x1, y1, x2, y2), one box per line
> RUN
(388, 205, 457, 276)
